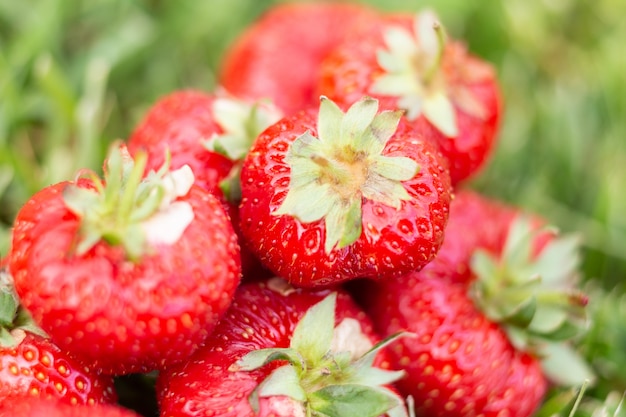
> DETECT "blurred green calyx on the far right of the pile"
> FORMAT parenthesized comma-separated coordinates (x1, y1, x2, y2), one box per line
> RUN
(470, 216, 593, 385)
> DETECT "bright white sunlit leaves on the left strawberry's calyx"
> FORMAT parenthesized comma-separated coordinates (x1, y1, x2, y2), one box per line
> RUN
(141, 165, 195, 245)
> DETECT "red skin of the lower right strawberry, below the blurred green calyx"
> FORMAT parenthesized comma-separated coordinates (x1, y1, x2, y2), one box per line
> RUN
(368, 272, 547, 417)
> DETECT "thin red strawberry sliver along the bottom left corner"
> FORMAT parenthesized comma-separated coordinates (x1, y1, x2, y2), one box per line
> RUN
(0, 397, 139, 417)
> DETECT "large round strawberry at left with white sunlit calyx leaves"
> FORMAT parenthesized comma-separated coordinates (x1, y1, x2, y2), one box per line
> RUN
(8, 146, 241, 374)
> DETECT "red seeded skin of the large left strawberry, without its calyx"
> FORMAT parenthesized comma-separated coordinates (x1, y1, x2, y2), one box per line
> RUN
(9, 180, 241, 374)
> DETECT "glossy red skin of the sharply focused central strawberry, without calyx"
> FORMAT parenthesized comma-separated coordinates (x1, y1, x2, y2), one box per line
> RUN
(240, 112, 451, 287)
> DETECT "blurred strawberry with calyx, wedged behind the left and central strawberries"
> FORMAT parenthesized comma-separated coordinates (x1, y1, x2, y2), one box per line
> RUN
(128, 90, 281, 271)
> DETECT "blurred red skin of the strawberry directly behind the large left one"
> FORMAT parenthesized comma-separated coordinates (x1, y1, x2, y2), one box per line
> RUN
(128, 90, 233, 199)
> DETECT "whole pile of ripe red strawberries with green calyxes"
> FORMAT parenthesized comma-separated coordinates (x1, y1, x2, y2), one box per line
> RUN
(0, 3, 592, 417)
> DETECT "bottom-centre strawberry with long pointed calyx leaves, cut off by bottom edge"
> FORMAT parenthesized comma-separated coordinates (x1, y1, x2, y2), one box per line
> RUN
(157, 278, 406, 417)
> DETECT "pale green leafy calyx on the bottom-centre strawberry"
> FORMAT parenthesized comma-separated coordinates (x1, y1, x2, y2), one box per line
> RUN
(231, 293, 407, 417)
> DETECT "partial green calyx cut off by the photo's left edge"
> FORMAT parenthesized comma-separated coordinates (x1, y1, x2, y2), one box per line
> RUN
(0, 268, 47, 348)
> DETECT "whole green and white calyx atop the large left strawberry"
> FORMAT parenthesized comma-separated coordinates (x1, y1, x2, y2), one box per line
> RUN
(63, 143, 194, 261)
